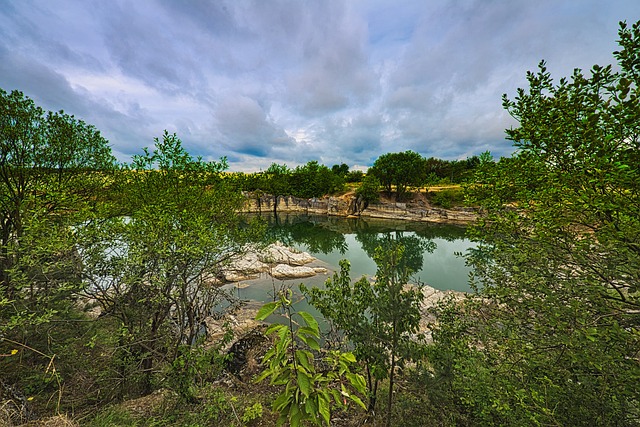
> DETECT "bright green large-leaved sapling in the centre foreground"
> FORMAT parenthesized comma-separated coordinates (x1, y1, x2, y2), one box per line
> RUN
(256, 289, 366, 427)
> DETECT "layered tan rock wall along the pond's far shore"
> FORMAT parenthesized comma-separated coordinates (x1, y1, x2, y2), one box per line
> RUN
(243, 193, 477, 224)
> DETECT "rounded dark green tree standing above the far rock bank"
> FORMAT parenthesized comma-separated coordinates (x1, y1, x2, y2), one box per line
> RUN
(368, 150, 426, 201)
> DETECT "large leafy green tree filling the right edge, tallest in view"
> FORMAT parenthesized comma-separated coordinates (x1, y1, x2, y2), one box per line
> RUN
(436, 23, 640, 426)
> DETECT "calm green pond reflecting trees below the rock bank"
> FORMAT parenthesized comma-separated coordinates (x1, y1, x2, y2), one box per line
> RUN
(228, 213, 475, 309)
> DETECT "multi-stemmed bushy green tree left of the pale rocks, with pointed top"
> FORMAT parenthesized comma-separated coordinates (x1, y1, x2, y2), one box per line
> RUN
(82, 131, 252, 397)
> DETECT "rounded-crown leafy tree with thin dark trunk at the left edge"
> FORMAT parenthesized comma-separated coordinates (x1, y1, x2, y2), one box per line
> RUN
(0, 89, 114, 299)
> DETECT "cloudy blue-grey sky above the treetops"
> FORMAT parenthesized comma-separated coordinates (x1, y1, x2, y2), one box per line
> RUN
(0, 0, 640, 172)
